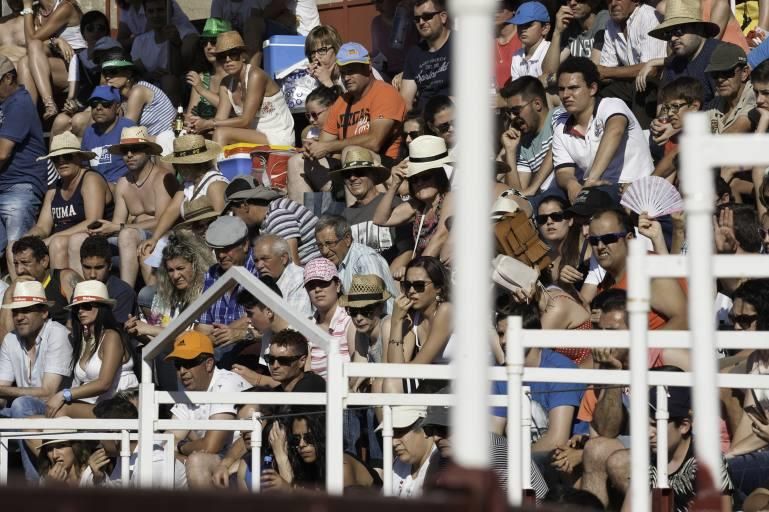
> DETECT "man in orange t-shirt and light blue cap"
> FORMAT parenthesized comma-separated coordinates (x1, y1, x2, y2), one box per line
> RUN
(306, 43, 406, 167)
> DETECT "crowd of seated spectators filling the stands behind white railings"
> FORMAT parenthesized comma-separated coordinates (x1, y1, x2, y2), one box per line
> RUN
(0, 0, 769, 511)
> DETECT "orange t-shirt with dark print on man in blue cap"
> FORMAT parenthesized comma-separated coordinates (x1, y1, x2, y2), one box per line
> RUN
(323, 79, 406, 158)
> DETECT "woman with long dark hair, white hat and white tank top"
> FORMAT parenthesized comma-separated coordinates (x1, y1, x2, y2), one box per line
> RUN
(47, 281, 139, 418)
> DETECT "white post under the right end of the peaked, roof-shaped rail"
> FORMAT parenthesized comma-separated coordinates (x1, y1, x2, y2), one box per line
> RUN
(326, 338, 347, 495)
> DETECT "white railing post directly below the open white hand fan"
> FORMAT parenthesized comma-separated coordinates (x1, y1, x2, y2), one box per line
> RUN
(626, 239, 650, 512)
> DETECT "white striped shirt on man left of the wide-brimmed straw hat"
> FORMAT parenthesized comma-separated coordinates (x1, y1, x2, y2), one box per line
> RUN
(601, 4, 668, 67)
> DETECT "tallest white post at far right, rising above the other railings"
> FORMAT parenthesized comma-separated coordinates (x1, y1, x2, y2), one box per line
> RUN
(680, 113, 721, 489)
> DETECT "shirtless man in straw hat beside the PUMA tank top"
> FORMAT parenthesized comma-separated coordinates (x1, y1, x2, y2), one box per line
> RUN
(88, 126, 178, 286)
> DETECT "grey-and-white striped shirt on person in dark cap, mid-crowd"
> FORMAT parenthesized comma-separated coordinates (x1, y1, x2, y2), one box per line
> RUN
(261, 197, 320, 265)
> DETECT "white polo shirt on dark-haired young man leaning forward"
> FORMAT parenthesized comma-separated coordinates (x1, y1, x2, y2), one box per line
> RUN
(553, 98, 654, 183)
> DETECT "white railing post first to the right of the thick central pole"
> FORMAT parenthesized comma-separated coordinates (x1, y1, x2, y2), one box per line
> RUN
(505, 316, 530, 507)
